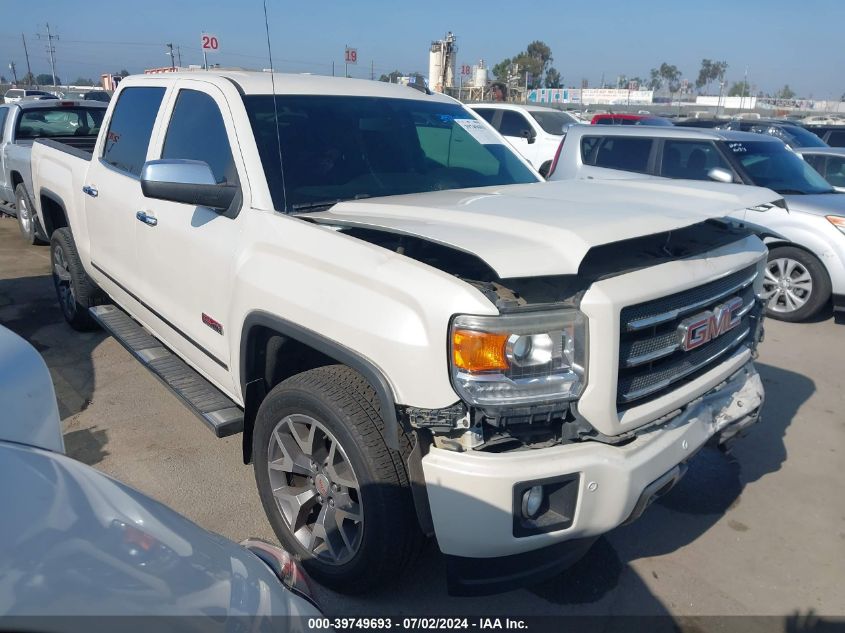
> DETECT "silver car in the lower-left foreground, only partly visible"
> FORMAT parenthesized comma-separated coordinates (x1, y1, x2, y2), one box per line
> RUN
(0, 326, 320, 631)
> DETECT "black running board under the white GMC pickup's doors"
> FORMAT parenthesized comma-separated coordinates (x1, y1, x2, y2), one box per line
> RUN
(89, 305, 244, 437)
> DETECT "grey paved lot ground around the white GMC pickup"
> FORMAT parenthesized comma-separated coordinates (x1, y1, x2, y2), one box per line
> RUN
(0, 217, 845, 616)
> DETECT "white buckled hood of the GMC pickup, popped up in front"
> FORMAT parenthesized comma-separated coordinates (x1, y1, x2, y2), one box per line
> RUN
(307, 178, 780, 278)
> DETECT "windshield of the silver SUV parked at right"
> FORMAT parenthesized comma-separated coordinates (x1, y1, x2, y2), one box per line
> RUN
(725, 141, 833, 195)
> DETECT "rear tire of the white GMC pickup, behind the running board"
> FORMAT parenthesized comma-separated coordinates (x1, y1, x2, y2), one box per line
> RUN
(50, 227, 105, 332)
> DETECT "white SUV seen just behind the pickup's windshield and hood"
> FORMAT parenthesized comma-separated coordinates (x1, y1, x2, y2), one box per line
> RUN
(469, 103, 581, 177)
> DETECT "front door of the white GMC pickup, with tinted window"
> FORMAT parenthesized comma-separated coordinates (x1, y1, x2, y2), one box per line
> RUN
(133, 79, 244, 392)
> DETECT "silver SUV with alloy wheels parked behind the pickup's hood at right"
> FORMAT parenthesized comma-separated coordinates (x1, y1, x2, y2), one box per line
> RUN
(549, 126, 845, 321)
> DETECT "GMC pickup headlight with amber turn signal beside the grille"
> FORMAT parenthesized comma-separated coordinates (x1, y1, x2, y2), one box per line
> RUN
(449, 309, 587, 407)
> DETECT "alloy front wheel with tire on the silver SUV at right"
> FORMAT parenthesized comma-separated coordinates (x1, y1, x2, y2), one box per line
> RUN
(763, 246, 831, 323)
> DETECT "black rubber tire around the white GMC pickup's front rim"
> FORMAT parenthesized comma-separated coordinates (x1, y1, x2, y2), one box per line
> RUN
(252, 365, 423, 594)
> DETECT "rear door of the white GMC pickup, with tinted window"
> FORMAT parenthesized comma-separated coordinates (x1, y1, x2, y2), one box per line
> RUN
(80, 85, 167, 288)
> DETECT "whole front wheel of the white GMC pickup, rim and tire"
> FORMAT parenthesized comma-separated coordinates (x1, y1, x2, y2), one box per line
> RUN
(253, 365, 422, 593)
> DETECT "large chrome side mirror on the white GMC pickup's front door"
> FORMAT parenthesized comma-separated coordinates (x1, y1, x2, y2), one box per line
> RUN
(141, 158, 238, 211)
